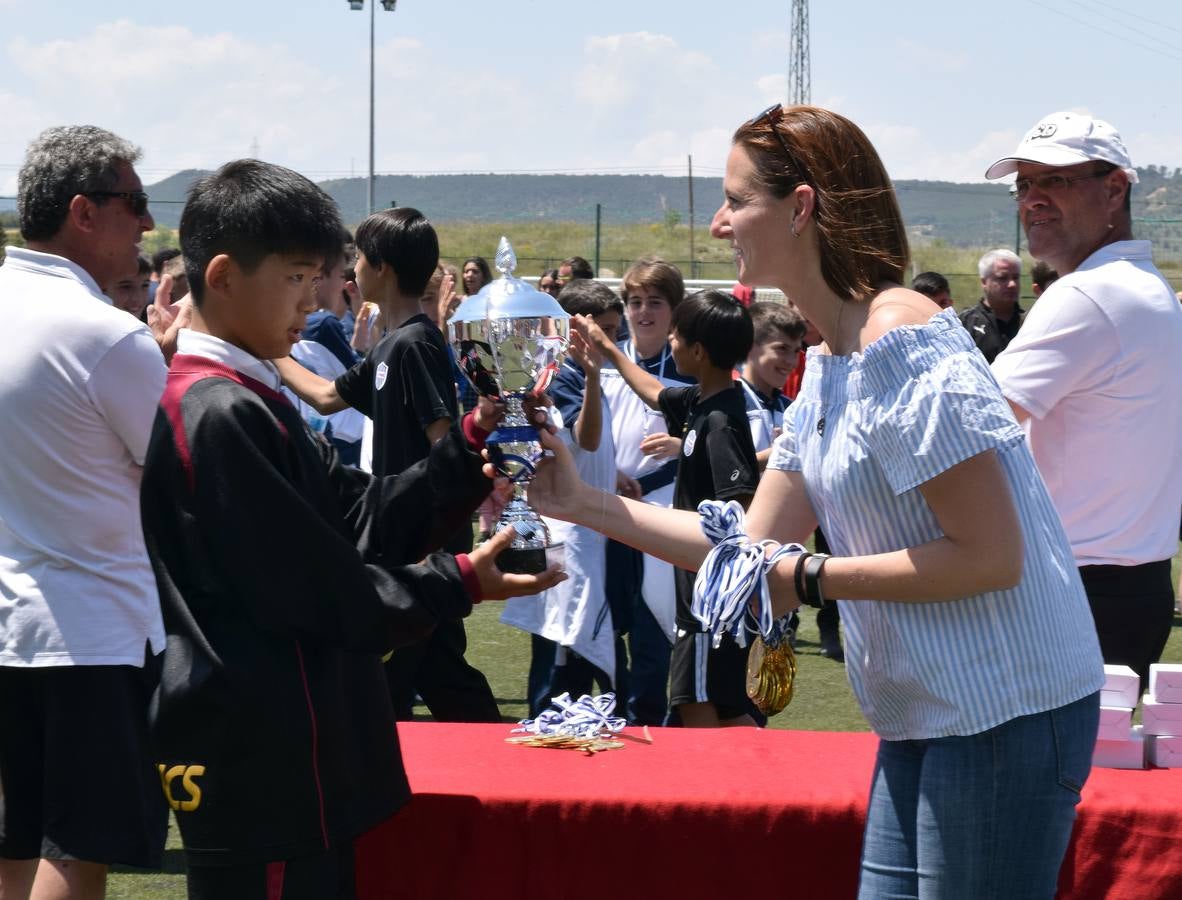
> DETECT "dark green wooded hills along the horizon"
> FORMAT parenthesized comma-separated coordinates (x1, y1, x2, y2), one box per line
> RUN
(135, 166, 1182, 254)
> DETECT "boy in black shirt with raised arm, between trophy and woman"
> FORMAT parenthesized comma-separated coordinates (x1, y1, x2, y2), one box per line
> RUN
(573, 291, 759, 727)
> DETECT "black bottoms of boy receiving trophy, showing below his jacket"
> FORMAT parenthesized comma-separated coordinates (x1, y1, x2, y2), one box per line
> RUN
(188, 841, 357, 900)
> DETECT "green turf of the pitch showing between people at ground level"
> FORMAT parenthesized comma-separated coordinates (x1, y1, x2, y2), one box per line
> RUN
(108, 565, 1182, 900)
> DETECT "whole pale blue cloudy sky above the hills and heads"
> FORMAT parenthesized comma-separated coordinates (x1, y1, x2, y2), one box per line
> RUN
(0, 0, 1182, 194)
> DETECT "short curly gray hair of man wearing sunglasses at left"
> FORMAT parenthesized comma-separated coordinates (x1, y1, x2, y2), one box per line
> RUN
(17, 125, 141, 240)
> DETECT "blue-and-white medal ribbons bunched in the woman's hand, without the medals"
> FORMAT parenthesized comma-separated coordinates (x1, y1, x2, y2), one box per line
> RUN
(690, 500, 805, 647)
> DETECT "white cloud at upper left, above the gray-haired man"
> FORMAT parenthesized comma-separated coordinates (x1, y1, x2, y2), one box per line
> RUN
(7, 21, 344, 171)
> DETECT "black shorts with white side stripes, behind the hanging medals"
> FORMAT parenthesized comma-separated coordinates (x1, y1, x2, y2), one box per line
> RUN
(669, 627, 752, 719)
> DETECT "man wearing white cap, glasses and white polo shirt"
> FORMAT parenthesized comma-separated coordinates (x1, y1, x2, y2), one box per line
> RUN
(985, 112, 1182, 682)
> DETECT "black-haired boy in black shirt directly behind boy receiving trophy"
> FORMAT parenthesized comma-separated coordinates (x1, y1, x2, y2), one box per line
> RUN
(277, 207, 501, 721)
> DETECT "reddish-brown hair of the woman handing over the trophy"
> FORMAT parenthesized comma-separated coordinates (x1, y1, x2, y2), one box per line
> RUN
(734, 106, 910, 300)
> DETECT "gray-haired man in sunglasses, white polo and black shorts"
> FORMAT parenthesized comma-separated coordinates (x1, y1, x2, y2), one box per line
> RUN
(0, 127, 167, 898)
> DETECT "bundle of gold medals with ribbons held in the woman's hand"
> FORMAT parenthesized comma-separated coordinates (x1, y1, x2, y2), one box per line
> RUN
(690, 500, 805, 716)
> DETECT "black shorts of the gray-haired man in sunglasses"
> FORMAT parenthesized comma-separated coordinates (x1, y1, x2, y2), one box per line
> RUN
(0, 661, 168, 868)
